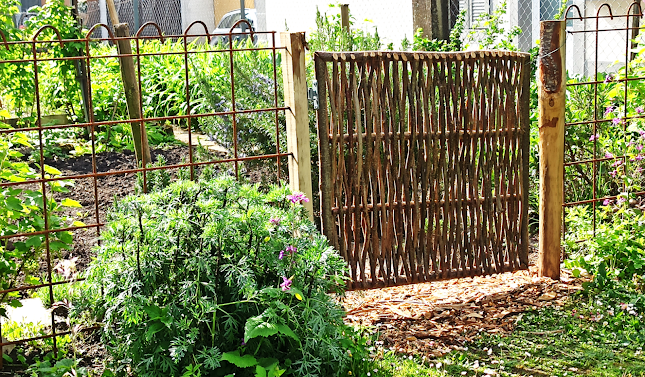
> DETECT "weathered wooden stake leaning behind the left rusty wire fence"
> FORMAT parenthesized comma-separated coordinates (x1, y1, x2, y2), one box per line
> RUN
(114, 22, 152, 166)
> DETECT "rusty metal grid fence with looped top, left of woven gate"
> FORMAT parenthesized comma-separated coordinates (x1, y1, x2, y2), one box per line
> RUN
(0, 21, 291, 356)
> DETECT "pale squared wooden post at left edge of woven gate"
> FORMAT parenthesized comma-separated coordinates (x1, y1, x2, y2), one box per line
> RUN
(280, 32, 314, 220)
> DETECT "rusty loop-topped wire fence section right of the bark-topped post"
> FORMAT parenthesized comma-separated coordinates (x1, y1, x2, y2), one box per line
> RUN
(563, 1, 645, 241)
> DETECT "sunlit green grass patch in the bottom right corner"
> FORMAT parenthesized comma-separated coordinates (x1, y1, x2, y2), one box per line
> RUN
(362, 284, 645, 377)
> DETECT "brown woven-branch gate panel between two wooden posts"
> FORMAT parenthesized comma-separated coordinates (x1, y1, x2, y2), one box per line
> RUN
(315, 51, 531, 289)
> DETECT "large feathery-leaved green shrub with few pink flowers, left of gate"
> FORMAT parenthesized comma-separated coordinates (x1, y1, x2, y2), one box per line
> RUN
(82, 177, 354, 376)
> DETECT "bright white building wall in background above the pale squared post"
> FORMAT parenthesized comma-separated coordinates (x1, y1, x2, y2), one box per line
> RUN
(258, 0, 413, 47)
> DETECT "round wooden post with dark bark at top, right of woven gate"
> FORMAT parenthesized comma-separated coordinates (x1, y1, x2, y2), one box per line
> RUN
(538, 20, 567, 279)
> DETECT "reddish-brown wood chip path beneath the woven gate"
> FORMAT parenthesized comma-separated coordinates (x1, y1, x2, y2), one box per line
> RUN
(341, 266, 584, 357)
